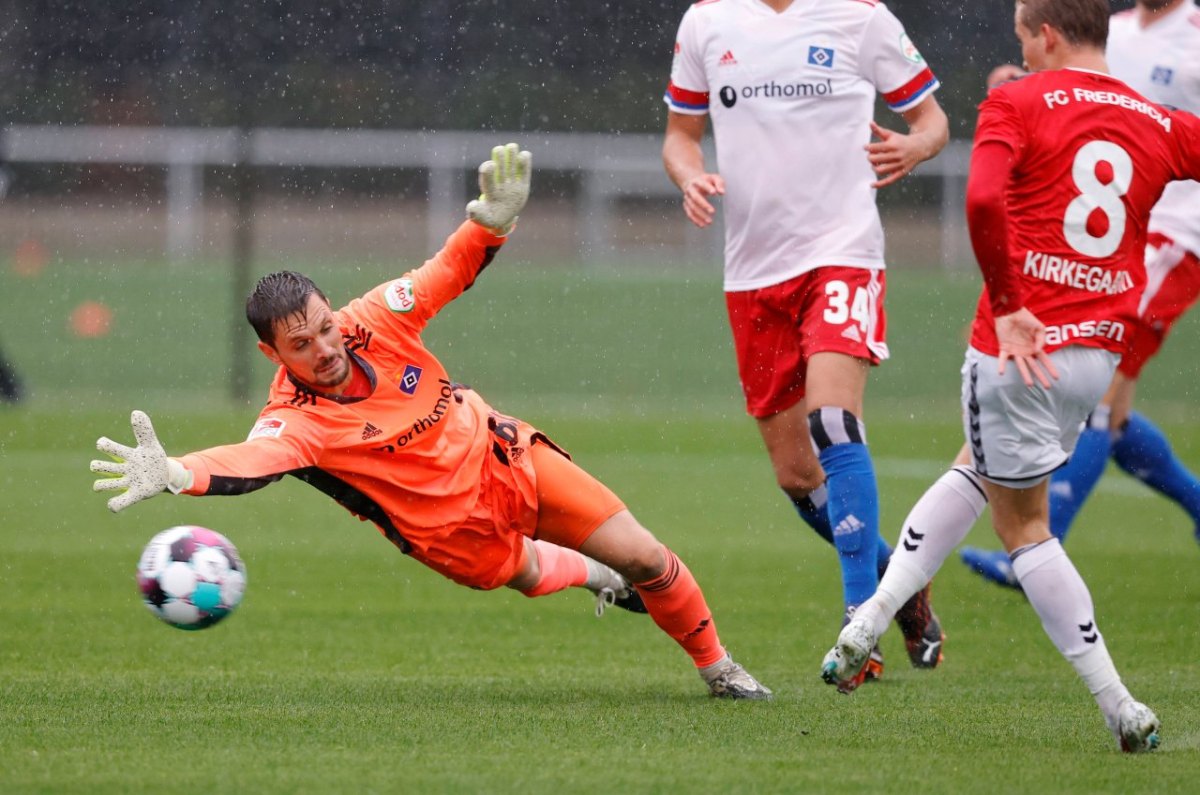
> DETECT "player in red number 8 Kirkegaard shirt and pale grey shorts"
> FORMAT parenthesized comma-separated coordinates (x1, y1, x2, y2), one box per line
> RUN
(821, 0, 1200, 752)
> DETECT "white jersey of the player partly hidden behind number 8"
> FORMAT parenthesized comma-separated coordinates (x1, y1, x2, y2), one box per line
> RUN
(1108, 2, 1200, 255)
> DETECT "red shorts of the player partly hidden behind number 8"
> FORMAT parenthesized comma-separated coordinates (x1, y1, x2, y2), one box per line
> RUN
(1117, 232, 1200, 381)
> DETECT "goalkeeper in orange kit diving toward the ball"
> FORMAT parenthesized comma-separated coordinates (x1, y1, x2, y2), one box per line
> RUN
(91, 144, 772, 699)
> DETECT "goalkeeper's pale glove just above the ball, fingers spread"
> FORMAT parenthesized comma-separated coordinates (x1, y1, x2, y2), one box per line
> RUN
(91, 411, 193, 514)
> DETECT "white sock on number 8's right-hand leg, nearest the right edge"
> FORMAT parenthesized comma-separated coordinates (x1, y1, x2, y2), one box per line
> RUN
(1013, 538, 1130, 727)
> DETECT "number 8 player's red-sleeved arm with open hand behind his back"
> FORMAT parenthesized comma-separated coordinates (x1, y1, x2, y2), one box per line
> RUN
(967, 141, 1058, 388)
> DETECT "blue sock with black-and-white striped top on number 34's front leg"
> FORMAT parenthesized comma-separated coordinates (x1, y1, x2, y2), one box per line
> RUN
(809, 407, 880, 606)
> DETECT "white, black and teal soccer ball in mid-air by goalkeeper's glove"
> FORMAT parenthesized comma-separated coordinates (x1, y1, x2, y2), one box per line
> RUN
(138, 525, 246, 629)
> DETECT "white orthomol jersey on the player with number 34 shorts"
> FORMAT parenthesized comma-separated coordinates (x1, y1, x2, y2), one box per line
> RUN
(664, 0, 938, 292)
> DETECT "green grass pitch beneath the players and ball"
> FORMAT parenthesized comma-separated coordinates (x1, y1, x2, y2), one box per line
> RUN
(0, 263, 1200, 794)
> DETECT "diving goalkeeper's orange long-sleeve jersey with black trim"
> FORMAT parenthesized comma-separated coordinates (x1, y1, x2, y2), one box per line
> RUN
(179, 221, 513, 552)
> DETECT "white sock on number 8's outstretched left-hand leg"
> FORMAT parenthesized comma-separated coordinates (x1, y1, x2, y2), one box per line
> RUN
(858, 466, 988, 636)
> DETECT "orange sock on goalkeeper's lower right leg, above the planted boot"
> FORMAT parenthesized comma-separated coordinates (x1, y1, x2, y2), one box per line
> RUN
(635, 546, 725, 668)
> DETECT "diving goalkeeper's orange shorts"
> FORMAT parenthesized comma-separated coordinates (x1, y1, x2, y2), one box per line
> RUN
(409, 412, 625, 591)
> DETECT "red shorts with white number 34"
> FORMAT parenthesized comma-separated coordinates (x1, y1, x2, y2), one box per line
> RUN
(725, 265, 888, 418)
